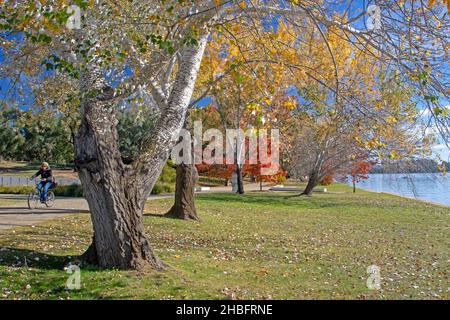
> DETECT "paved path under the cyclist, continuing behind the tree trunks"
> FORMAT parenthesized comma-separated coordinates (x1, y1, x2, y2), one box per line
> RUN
(0, 183, 268, 230)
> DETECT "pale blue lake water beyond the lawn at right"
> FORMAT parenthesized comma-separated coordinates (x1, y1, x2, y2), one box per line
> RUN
(349, 173, 450, 205)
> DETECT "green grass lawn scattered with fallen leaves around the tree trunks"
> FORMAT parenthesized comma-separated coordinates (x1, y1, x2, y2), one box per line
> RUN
(0, 185, 450, 299)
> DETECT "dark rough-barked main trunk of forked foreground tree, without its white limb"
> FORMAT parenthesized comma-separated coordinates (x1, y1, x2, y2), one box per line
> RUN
(75, 74, 164, 269)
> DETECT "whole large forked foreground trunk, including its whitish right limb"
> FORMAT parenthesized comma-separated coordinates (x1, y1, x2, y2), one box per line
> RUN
(75, 36, 207, 269)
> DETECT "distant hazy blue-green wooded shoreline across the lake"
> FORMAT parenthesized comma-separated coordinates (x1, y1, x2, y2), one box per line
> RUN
(371, 159, 450, 173)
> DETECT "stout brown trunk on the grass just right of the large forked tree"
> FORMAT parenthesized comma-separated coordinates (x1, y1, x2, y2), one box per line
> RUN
(165, 163, 200, 220)
